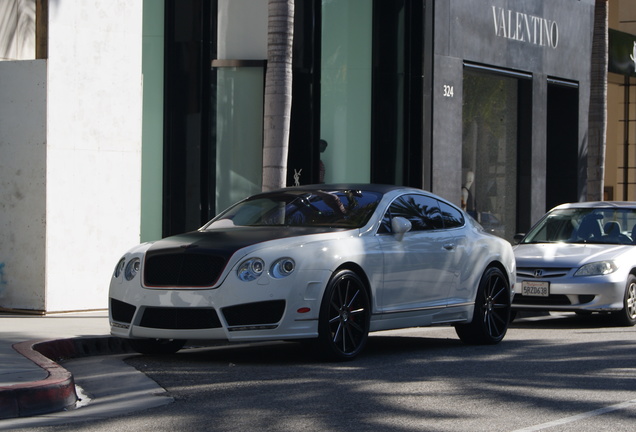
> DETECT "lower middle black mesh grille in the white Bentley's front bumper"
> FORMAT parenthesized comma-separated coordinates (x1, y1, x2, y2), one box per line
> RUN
(140, 307, 221, 330)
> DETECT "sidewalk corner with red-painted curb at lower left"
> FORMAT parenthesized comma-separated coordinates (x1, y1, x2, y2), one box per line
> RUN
(0, 311, 130, 419)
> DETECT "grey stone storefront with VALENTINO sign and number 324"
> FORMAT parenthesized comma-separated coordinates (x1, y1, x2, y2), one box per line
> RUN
(424, 1, 593, 240)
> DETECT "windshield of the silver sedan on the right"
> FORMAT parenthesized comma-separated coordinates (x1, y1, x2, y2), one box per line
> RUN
(521, 208, 636, 244)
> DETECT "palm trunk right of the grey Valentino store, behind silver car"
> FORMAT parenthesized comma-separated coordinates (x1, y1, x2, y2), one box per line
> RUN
(587, 0, 608, 201)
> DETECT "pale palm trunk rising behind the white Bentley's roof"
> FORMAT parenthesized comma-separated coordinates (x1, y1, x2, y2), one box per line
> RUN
(263, 0, 294, 191)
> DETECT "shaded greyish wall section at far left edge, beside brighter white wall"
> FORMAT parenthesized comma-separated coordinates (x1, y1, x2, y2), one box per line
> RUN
(0, 60, 46, 310)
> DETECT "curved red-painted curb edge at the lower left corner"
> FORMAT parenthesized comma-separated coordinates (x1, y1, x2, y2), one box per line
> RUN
(0, 336, 134, 420)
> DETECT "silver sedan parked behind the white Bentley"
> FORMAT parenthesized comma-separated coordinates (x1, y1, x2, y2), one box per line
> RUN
(512, 202, 636, 326)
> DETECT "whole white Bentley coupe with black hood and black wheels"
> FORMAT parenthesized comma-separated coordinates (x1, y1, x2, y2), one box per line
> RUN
(109, 184, 515, 360)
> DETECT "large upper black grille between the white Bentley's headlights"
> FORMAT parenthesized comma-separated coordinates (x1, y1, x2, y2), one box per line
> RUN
(144, 253, 225, 287)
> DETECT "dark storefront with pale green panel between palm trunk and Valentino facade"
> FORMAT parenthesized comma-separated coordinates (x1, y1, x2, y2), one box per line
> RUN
(287, 0, 432, 187)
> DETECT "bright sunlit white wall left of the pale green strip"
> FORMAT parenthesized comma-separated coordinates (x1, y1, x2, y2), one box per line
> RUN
(46, 0, 142, 312)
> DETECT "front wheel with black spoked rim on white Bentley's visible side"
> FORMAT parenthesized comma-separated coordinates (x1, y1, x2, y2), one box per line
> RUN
(317, 270, 371, 361)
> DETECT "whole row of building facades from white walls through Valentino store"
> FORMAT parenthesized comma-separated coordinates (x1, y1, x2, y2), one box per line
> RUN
(0, 0, 594, 313)
